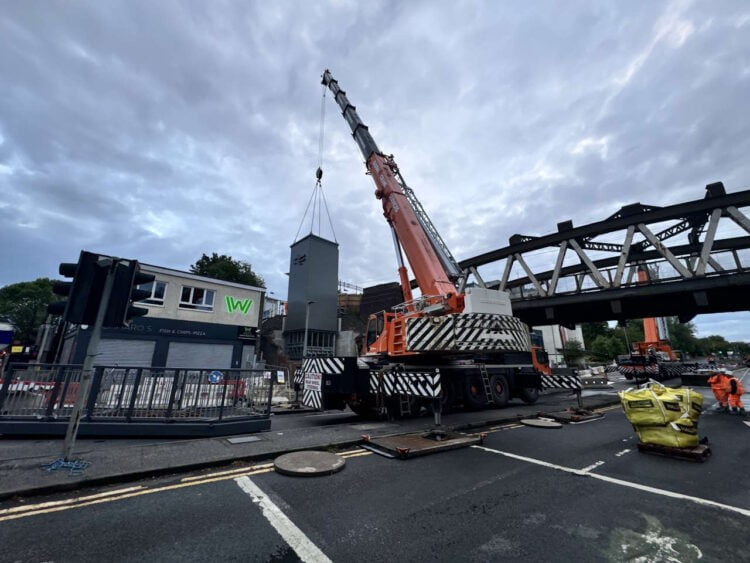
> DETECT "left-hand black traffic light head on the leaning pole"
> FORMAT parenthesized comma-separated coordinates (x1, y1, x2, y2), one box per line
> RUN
(47, 250, 107, 325)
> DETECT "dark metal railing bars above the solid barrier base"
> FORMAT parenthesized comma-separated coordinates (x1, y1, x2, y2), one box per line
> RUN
(0, 364, 282, 422)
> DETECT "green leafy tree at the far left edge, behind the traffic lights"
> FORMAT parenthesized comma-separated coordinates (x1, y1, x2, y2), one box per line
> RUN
(0, 278, 59, 344)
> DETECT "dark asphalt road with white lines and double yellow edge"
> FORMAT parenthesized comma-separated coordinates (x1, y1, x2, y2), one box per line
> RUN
(0, 378, 750, 562)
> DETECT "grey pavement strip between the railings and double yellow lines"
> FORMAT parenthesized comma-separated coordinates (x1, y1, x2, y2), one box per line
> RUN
(0, 386, 619, 501)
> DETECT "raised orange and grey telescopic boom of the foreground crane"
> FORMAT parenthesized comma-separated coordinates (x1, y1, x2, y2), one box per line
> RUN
(323, 70, 464, 313)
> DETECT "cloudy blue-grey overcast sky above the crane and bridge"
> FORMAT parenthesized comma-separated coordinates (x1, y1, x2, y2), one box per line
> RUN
(0, 0, 750, 340)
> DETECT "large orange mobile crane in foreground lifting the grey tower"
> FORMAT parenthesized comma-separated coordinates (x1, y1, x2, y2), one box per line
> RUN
(297, 70, 541, 417)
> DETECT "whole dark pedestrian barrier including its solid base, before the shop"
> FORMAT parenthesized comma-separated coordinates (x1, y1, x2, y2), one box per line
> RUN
(0, 364, 287, 435)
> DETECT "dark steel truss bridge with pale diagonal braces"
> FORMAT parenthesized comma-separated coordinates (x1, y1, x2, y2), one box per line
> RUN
(459, 182, 750, 326)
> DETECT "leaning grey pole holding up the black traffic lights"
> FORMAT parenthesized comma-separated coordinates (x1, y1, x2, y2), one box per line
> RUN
(63, 257, 117, 461)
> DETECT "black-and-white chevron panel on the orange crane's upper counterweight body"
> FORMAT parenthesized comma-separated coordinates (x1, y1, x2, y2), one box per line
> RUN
(406, 313, 530, 352)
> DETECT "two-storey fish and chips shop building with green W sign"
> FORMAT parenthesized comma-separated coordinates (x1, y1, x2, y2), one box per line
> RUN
(59, 264, 266, 369)
